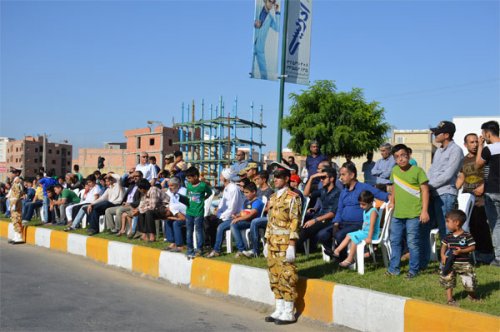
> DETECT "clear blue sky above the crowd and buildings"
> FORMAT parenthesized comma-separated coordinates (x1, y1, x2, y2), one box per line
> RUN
(0, 0, 500, 157)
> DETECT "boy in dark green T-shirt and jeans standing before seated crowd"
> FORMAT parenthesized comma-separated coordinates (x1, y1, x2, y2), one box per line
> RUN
(185, 166, 212, 259)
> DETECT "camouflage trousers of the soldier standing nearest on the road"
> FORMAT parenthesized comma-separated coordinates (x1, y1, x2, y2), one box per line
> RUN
(267, 251, 299, 302)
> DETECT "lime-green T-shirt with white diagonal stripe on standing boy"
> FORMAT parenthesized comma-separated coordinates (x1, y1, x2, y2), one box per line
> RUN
(391, 165, 429, 219)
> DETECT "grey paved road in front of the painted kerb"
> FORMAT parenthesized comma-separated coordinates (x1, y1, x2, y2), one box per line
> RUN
(0, 239, 352, 332)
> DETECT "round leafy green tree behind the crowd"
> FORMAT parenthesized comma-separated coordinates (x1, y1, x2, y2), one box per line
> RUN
(283, 80, 390, 157)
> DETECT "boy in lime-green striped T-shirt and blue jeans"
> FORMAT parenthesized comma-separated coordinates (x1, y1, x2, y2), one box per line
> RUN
(386, 144, 429, 279)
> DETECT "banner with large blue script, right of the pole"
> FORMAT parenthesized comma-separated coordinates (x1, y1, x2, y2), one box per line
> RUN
(283, 0, 312, 85)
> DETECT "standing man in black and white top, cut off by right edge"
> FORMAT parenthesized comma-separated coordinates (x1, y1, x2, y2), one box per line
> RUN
(476, 121, 500, 266)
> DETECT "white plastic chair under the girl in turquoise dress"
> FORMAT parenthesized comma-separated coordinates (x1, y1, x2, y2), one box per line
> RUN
(356, 204, 392, 274)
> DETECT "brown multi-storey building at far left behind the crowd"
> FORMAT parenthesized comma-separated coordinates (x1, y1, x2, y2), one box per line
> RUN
(2, 136, 73, 178)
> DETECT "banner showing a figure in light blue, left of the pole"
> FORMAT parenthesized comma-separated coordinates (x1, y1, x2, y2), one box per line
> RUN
(250, 0, 281, 81)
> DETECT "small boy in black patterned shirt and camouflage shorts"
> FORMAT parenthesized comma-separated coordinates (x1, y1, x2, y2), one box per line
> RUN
(439, 210, 479, 306)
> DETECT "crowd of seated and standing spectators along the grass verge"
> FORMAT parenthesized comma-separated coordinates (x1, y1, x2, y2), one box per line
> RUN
(0, 121, 500, 286)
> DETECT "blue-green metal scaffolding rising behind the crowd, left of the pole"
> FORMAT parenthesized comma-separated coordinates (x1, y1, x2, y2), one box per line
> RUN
(174, 97, 266, 184)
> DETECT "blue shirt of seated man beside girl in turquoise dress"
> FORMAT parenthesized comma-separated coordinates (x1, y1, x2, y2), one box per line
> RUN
(333, 182, 389, 224)
